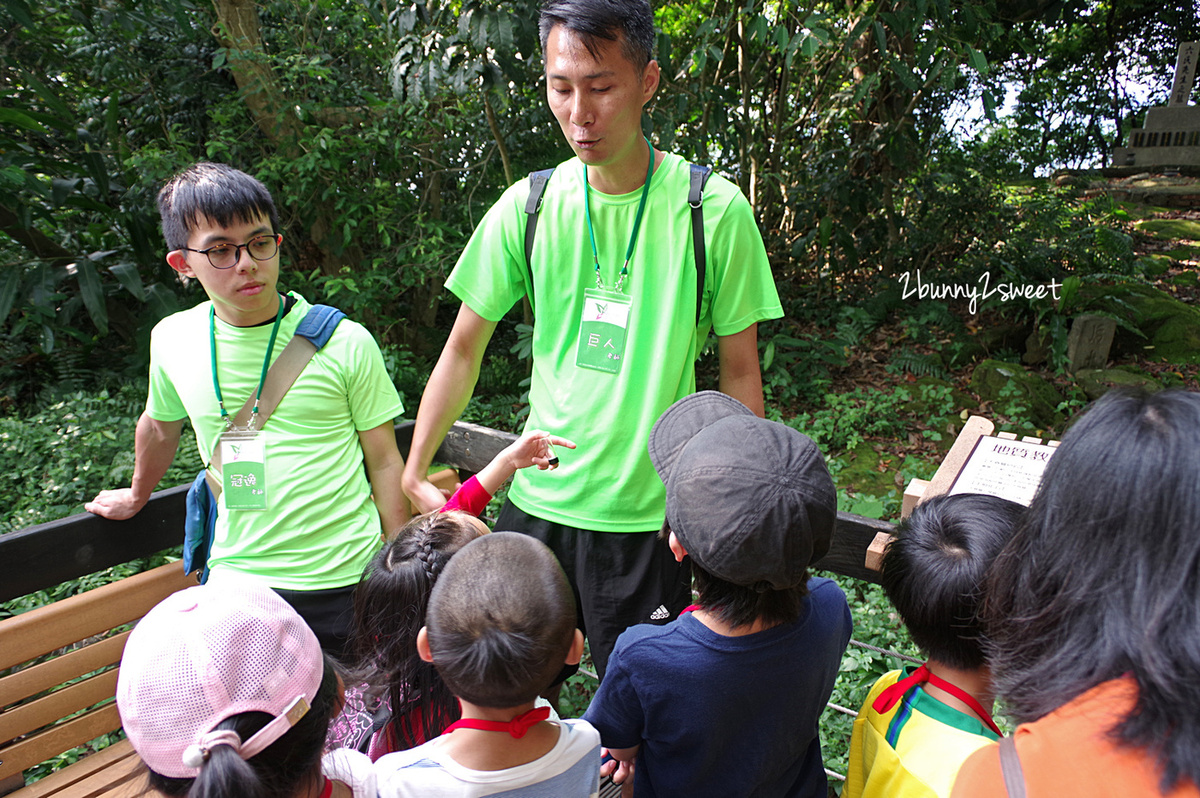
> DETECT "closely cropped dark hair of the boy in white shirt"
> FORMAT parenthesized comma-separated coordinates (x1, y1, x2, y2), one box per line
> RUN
(425, 532, 575, 709)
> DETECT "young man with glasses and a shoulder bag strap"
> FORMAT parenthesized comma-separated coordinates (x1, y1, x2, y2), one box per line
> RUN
(85, 163, 408, 653)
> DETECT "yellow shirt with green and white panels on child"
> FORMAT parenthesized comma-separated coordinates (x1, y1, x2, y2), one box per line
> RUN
(841, 671, 998, 798)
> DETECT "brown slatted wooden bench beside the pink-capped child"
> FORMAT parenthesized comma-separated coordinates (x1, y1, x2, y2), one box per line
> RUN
(0, 563, 197, 798)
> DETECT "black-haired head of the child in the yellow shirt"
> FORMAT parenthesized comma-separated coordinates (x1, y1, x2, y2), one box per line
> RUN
(881, 493, 1025, 670)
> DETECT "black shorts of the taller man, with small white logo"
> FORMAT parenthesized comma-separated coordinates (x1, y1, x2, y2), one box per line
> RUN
(496, 500, 691, 679)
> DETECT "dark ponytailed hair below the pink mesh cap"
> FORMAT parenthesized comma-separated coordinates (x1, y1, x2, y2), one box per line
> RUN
(146, 656, 340, 798)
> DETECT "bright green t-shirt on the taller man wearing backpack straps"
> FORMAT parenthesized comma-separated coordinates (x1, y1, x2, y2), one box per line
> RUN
(446, 155, 784, 532)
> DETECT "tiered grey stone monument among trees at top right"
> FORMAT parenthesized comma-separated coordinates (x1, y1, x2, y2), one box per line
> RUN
(1112, 42, 1200, 167)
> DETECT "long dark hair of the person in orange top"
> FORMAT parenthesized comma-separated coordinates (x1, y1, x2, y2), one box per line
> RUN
(983, 390, 1200, 794)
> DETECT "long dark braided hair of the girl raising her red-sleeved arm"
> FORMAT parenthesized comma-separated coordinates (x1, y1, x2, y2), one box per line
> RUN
(350, 511, 479, 750)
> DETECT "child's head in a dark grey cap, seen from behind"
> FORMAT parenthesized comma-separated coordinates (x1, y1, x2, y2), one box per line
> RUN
(649, 391, 838, 626)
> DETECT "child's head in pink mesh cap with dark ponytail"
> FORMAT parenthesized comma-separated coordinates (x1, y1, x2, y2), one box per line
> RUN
(116, 577, 340, 798)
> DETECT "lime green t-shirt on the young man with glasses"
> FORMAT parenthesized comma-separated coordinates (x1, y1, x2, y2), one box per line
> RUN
(146, 291, 403, 590)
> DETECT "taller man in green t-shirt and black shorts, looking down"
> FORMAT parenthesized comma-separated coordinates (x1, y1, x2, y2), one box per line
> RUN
(404, 0, 782, 674)
